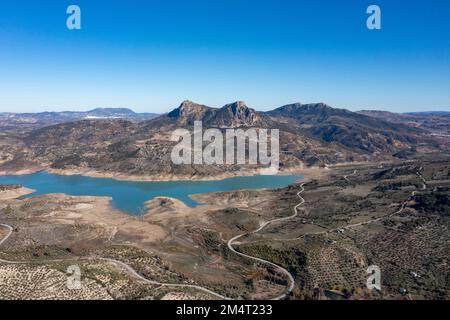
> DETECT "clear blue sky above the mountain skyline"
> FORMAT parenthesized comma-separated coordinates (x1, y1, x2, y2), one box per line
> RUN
(0, 0, 450, 112)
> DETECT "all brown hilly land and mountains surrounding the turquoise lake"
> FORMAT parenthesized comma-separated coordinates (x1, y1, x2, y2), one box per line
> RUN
(0, 101, 450, 300)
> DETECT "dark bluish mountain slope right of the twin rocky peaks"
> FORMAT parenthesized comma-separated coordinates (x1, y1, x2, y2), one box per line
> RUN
(266, 103, 433, 154)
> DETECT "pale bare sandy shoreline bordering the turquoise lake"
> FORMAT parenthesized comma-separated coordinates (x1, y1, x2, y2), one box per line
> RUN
(0, 168, 328, 240)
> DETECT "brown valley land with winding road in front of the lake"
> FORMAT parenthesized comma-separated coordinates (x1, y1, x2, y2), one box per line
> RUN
(0, 161, 450, 299)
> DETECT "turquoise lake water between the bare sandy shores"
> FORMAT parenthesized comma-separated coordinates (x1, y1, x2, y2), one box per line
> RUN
(0, 172, 302, 215)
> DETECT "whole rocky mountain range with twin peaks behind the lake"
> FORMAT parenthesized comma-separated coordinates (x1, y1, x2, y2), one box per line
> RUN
(0, 101, 443, 178)
